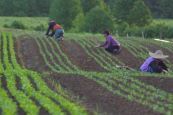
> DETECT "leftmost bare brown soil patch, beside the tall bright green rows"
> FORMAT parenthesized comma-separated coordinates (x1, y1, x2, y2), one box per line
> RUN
(15, 36, 49, 72)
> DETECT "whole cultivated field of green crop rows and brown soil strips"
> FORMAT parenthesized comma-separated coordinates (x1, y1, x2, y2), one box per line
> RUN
(0, 30, 173, 115)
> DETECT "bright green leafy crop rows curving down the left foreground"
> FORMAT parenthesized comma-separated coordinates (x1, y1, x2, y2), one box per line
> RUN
(0, 33, 86, 115)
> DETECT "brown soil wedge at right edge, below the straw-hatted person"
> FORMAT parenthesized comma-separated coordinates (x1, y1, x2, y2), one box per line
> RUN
(139, 77, 173, 93)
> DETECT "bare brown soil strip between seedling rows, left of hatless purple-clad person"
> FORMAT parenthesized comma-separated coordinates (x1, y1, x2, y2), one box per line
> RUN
(60, 40, 105, 72)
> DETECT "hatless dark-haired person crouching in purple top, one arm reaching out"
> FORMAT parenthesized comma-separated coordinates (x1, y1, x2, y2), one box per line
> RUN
(96, 30, 120, 54)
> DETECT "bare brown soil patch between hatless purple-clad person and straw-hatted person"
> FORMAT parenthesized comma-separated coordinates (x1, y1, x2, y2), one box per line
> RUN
(115, 47, 143, 69)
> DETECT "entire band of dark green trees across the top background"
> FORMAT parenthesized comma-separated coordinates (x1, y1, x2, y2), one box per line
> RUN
(0, 0, 173, 37)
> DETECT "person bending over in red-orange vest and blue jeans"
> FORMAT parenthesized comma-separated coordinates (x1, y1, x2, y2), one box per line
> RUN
(46, 20, 64, 40)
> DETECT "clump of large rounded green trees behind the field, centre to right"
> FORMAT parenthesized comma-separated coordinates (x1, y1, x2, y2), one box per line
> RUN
(49, 0, 152, 33)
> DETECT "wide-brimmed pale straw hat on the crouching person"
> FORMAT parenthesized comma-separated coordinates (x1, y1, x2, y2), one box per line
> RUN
(149, 50, 169, 59)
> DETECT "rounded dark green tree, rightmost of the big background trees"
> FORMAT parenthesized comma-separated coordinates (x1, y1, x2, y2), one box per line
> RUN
(127, 0, 152, 26)
